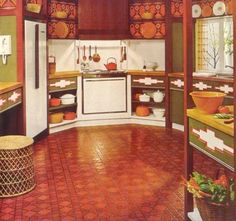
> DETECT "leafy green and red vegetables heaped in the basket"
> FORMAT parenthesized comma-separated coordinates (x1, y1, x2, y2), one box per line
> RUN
(184, 172, 235, 205)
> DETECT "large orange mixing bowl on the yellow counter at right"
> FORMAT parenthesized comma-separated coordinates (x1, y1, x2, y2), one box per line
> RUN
(190, 91, 225, 114)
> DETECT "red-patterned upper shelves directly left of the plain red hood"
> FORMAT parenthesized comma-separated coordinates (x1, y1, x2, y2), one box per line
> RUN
(48, 0, 78, 39)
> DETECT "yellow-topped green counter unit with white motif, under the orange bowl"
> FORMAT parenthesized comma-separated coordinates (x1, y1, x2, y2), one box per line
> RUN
(187, 109, 234, 171)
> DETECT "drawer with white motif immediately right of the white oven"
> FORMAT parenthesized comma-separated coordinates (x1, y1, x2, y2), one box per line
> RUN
(131, 75, 165, 88)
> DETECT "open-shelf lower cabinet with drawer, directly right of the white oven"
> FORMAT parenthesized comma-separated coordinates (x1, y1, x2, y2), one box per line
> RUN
(131, 74, 165, 121)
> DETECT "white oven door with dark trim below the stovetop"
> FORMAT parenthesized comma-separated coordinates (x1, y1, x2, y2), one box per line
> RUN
(83, 77, 127, 114)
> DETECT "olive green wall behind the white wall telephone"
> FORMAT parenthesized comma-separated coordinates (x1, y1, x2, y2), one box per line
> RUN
(0, 16, 17, 82)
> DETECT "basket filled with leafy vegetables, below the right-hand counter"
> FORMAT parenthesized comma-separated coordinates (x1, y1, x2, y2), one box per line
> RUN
(184, 172, 234, 221)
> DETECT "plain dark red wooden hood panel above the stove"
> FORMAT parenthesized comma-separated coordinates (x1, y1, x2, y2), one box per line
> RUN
(78, 0, 129, 39)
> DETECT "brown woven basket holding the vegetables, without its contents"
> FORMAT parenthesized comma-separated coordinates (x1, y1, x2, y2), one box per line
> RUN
(195, 198, 234, 221)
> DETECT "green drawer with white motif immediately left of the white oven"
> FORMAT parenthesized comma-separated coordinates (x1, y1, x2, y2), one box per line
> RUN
(49, 77, 77, 92)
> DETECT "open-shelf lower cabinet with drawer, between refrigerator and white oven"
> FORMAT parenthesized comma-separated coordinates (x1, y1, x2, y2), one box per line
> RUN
(49, 76, 77, 128)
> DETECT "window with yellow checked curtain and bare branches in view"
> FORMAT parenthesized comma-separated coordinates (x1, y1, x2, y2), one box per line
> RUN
(195, 16, 233, 73)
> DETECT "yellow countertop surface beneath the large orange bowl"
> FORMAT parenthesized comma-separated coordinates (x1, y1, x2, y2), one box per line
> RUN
(187, 109, 234, 136)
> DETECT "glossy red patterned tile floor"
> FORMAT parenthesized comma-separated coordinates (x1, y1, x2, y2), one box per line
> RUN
(0, 125, 227, 221)
